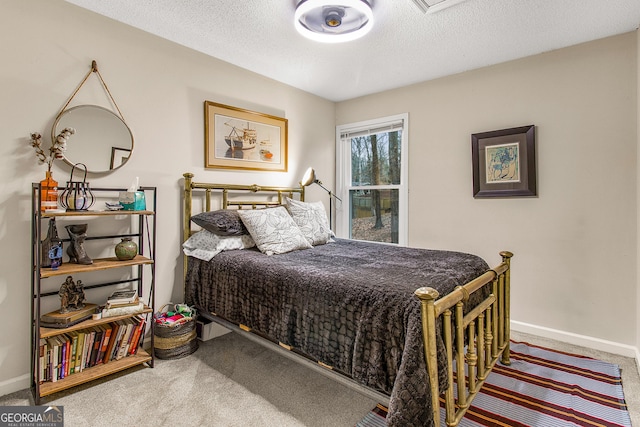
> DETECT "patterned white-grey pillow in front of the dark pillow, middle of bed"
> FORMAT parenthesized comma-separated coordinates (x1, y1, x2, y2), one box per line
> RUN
(238, 206, 312, 255)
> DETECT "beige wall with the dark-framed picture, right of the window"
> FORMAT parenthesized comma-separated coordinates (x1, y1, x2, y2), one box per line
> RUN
(336, 32, 638, 354)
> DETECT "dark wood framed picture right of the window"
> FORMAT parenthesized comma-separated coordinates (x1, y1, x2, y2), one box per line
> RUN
(471, 125, 537, 198)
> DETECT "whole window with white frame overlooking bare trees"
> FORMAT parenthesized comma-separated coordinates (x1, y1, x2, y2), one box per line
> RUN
(336, 114, 409, 245)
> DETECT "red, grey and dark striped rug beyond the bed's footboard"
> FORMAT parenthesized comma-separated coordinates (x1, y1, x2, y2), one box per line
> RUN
(356, 341, 631, 427)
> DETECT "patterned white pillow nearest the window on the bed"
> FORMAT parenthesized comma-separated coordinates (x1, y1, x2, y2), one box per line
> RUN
(285, 197, 333, 246)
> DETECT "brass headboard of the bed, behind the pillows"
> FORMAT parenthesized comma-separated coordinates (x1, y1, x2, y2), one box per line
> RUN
(182, 172, 304, 276)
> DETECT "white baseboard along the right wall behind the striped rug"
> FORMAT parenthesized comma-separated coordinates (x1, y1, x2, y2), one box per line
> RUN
(511, 320, 640, 367)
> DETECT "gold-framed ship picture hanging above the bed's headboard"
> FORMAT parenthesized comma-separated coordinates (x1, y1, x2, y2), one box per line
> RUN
(204, 101, 288, 172)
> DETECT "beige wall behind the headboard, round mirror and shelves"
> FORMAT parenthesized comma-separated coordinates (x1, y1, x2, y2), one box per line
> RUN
(0, 0, 335, 395)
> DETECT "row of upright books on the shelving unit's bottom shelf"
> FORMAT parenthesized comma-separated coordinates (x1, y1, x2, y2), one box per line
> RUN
(38, 316, 146, 383)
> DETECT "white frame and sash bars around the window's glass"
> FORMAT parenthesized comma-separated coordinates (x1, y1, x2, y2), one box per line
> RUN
(335, 113, 409, 246)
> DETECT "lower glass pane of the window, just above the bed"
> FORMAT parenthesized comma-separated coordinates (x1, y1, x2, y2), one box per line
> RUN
(349, 189, 399, 243)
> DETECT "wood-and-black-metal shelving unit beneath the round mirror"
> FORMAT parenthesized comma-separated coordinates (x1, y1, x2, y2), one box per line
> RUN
(31, 183, 156, 405)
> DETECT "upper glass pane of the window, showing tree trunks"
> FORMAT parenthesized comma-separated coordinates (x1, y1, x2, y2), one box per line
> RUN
(351, 131, 402, 187)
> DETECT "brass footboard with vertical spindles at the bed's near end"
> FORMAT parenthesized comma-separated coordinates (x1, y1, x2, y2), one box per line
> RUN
(415, 251, 513, 427)
